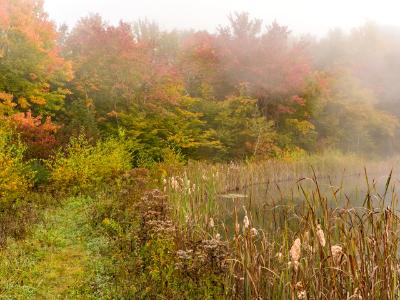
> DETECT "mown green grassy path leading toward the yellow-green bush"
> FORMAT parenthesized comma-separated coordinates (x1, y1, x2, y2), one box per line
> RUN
(0, 198, 113, 299)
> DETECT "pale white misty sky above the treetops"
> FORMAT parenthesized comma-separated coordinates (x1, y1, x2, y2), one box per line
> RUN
(45, 0, 400, 35)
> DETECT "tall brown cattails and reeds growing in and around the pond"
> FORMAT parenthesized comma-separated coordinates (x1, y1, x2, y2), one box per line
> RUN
(164, 156, 400, 299)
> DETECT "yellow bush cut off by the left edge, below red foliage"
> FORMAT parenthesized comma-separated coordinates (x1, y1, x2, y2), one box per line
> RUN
(0, 123, 34, 207)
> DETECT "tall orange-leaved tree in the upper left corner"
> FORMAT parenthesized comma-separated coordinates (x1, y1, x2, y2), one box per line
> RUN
(0, 0, 72, 115)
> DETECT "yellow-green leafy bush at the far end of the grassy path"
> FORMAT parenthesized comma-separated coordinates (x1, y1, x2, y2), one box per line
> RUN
(48, 135, 131, 191)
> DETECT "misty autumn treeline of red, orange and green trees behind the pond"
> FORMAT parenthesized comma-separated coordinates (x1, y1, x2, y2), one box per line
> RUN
(0, 0, 400, 165)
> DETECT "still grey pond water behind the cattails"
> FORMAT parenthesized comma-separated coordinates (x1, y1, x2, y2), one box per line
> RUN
(218, 171, 399, 229)
